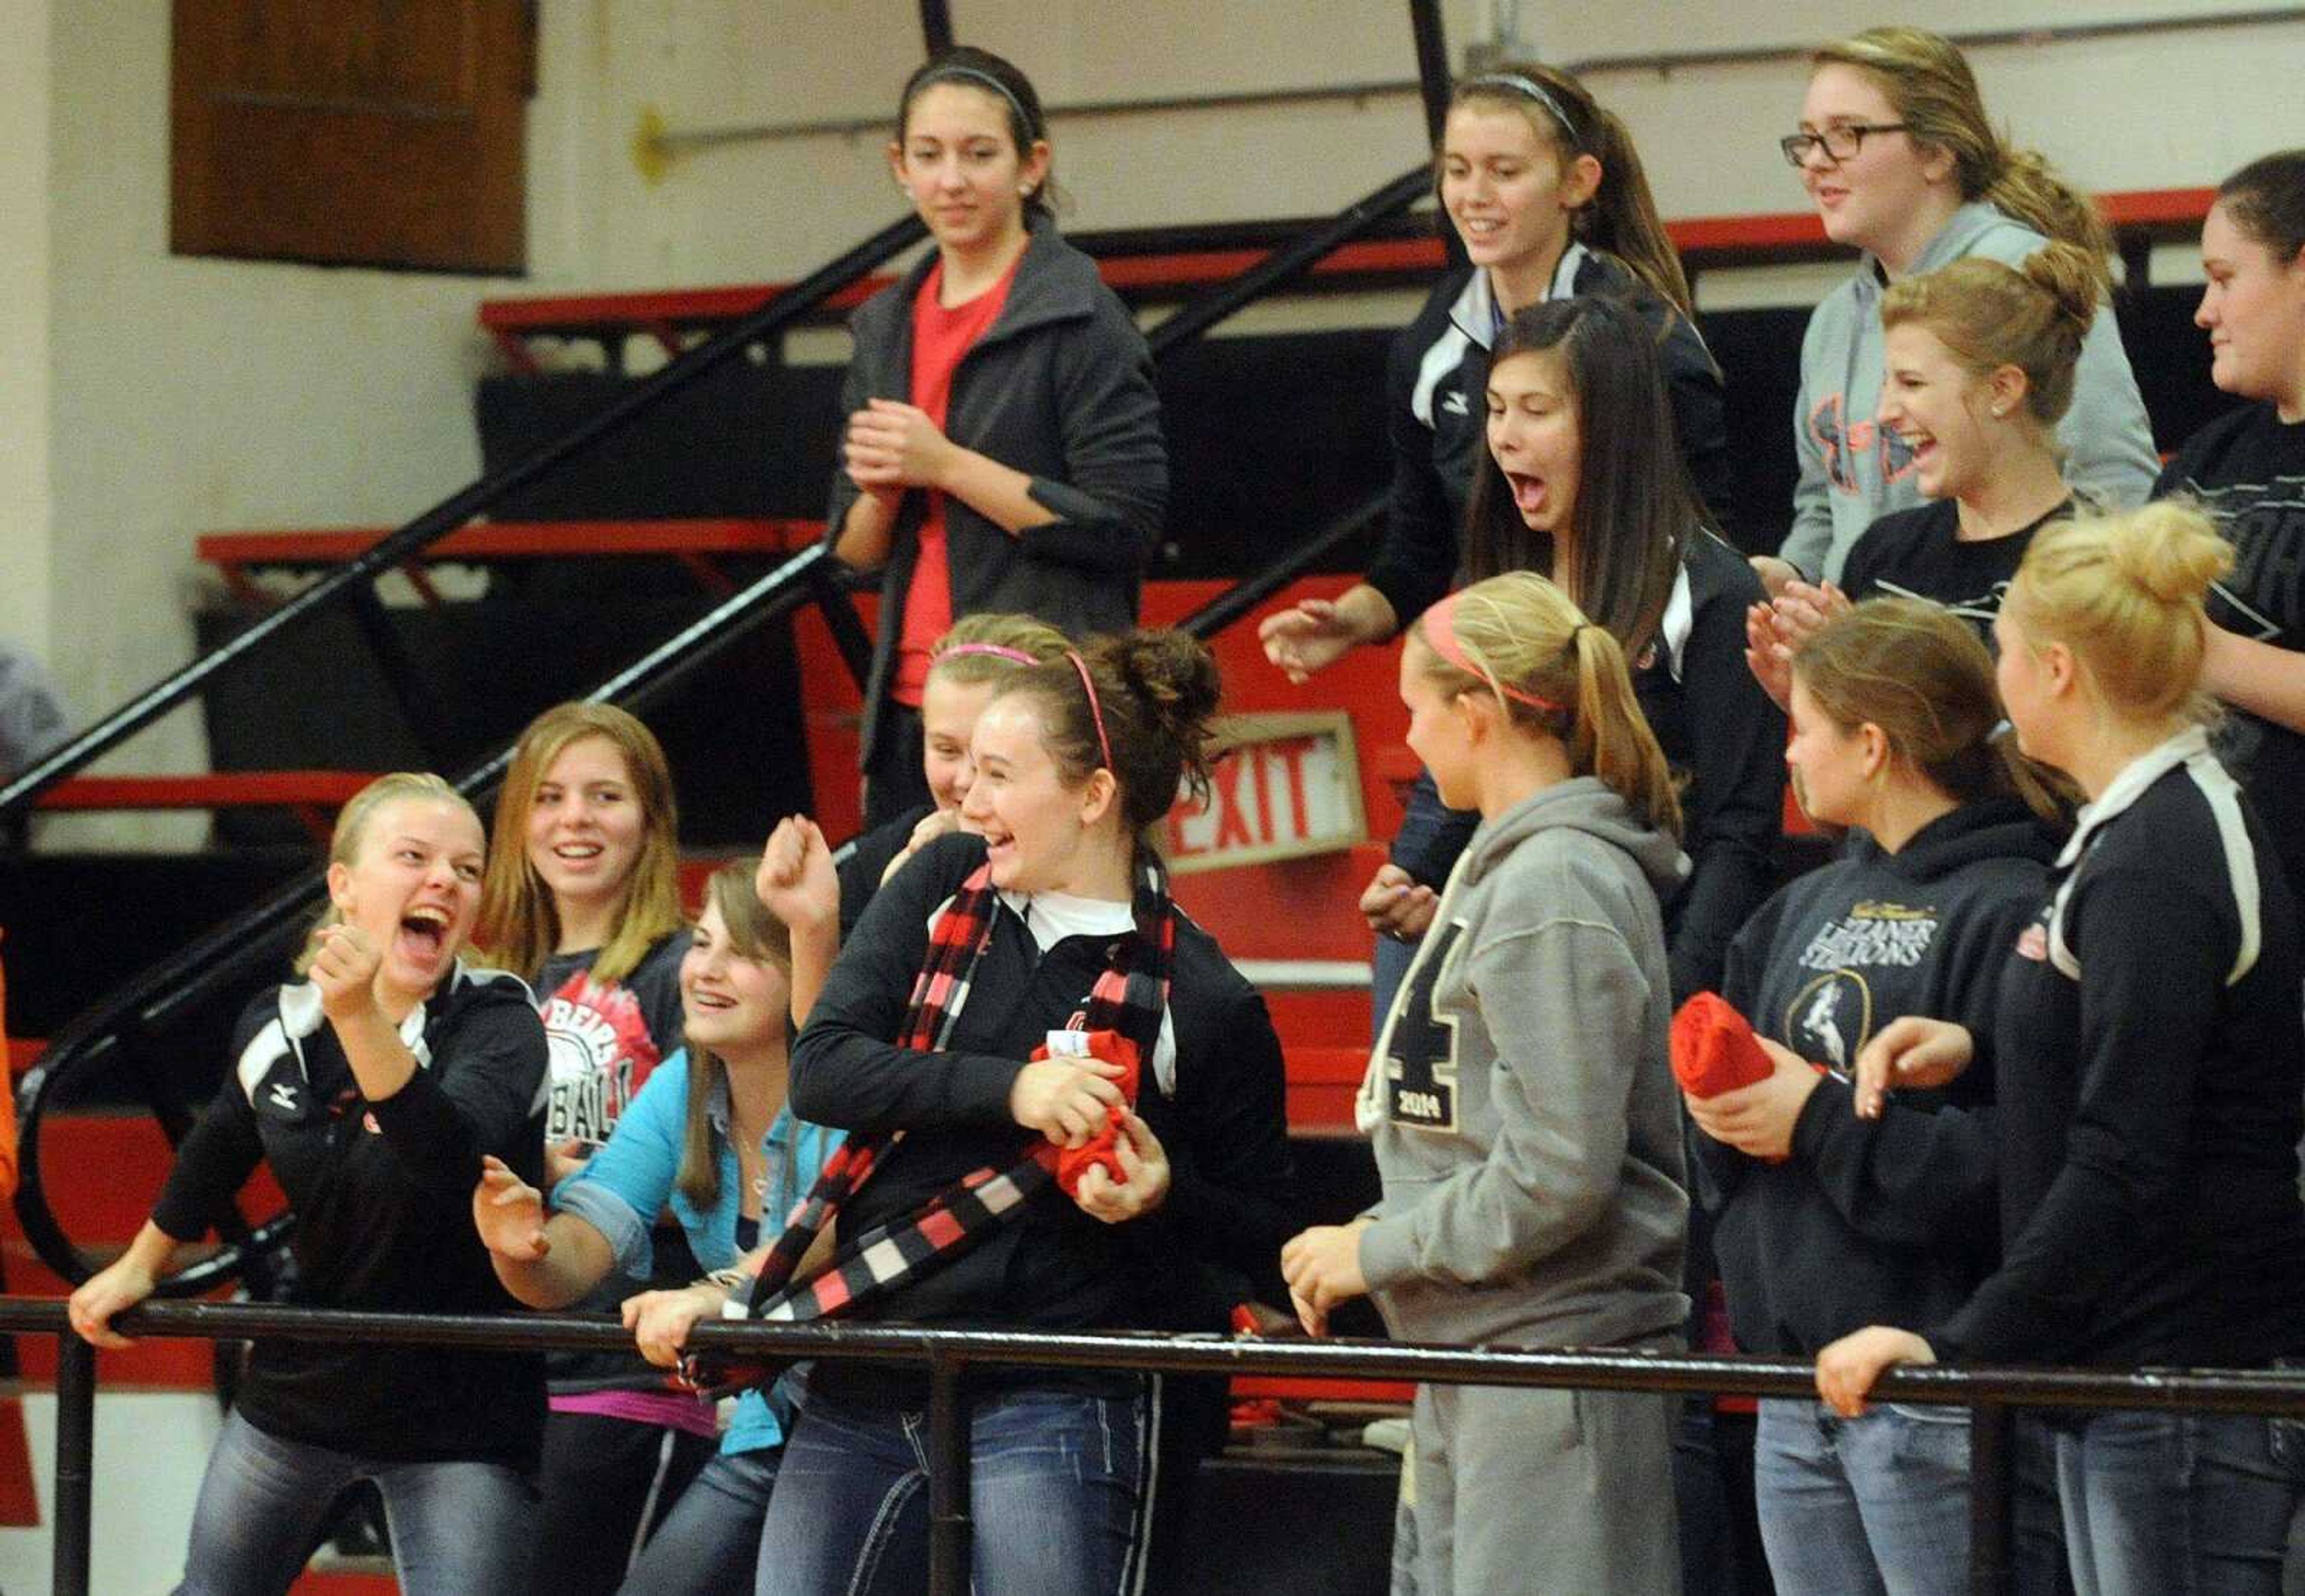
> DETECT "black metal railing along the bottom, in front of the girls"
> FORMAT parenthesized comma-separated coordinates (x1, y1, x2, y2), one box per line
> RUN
(0, 1296, 2305, 1596)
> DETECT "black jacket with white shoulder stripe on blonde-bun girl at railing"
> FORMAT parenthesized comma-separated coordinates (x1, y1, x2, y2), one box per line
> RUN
(1929, 729, 2305, 1368)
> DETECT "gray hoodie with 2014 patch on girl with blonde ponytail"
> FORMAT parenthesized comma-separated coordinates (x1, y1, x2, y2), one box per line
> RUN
(1358, 777, 1690, 1347)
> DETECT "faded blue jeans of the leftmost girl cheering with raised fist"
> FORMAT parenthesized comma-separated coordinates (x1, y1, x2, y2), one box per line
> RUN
(175, 1414, 537, 1596)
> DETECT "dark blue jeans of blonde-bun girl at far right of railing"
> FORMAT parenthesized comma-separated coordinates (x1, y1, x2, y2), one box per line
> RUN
(2047, 1414, 2300, 1596)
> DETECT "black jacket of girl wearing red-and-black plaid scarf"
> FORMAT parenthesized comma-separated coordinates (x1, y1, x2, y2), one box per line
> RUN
(793, 835, 1295, 1331)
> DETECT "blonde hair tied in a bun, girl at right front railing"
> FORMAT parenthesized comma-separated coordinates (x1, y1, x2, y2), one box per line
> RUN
(2001, 498, 2234, 720)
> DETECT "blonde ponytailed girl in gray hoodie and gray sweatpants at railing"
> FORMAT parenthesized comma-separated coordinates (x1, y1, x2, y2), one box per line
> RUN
(1282, 572, 1687, 1596)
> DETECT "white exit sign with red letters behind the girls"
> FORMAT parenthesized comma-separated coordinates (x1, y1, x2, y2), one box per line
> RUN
(1166, 710, 1369, 874)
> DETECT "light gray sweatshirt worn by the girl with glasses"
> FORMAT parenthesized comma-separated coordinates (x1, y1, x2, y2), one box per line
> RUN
(1777, 200, 2160, 581)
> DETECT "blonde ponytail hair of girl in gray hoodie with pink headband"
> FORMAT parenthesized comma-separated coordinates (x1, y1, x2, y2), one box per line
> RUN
(1415, 572, 1680, 835)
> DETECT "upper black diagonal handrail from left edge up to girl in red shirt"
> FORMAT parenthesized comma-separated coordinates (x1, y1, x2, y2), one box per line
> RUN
(0, 217, 927, 824)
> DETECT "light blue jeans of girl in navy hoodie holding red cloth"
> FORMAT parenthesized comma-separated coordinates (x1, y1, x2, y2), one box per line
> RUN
(1754, 1398, 1968, 1596)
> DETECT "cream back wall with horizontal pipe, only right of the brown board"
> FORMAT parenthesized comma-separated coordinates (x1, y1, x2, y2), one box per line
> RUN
(530, 0, 2305, 288)
